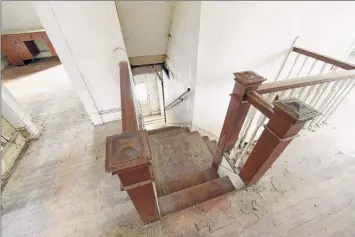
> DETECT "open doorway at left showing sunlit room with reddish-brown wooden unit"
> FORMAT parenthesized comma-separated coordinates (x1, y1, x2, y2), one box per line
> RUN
(1, 1, 81, 127)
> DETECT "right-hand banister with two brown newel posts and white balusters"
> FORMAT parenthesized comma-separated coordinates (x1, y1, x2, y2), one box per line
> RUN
(214, 47, 355, 184)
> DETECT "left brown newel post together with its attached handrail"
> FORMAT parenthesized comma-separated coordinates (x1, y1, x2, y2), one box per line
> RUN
(105, 62, 160, 223)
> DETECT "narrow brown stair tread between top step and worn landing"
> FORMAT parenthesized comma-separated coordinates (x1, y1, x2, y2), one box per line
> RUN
(157, 167, 219, 197)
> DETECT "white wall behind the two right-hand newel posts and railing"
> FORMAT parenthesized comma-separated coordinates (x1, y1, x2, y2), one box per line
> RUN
(193, 2, 355, 135)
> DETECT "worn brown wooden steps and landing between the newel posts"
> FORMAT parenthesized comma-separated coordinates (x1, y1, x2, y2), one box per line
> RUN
(148, 127, 235, 216)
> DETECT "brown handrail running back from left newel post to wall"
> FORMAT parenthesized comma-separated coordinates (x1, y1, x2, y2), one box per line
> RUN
(120, 61, 139, 133)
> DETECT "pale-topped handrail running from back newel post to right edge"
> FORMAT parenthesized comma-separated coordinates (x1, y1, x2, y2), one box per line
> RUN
(257, 70, 355, 94)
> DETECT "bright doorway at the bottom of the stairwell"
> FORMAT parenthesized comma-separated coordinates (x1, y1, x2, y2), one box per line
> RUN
(133, 72, 165, 129)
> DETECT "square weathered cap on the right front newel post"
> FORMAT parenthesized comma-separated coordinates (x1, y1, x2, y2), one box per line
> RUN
(273, 98, 321, 124)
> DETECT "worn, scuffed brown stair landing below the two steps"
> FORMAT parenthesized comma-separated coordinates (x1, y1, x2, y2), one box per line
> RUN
(149, 128, 213, 193)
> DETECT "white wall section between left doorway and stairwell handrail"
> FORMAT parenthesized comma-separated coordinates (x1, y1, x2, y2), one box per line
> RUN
(34, 1, 128, 124)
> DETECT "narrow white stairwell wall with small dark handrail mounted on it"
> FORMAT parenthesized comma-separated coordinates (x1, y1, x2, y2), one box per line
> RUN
(164, 1, 201, 123)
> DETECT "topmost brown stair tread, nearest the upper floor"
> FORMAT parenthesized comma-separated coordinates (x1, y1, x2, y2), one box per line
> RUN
(158, 176, 235, 216)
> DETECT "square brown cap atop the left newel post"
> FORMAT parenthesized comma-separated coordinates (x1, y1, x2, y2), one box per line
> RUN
(105, 130, 152, 173)
